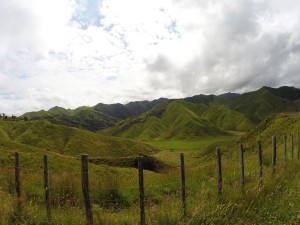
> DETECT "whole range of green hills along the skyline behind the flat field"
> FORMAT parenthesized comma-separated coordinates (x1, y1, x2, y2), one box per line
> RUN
(20, 86, 300, 140)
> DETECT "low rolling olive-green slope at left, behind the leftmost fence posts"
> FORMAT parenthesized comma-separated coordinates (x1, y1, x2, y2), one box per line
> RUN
(0, 120, 156, 157)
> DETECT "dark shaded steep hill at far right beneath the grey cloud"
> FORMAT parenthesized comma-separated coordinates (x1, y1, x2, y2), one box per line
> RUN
(227, 87, 300, 123)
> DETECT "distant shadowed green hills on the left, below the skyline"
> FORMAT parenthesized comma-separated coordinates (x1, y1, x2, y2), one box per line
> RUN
(20, 98, 167, 131)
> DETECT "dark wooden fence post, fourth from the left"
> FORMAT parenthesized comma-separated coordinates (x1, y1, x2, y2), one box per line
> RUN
(138, 155, 146, 225)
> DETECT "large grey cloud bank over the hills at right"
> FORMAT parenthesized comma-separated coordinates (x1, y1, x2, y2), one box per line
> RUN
(147, 0, 300, 95)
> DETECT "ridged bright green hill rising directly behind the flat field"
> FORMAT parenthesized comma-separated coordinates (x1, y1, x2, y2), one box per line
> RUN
(106, 100, 253, 140)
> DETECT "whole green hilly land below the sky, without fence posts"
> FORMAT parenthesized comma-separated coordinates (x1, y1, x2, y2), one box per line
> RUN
(0, 87, 300, 224)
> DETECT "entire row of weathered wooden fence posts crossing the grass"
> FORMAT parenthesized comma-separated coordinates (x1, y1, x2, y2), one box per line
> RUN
(4, 135, 300, 225)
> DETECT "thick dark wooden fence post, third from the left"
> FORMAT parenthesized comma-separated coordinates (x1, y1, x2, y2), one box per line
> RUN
(81, 154, 93, 225)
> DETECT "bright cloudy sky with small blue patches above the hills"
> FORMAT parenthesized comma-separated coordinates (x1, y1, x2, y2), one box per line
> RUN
(0, 0, 300, 115)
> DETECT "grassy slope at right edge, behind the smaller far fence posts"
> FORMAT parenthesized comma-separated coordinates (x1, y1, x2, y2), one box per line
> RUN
(200, 113, 300, 160)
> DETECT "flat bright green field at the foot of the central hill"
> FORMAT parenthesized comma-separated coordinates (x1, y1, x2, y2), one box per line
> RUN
(146, 136, 239, 150)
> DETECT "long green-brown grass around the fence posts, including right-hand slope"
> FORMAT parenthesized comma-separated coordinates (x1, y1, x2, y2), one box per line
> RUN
(0, 115, 300, 225)
